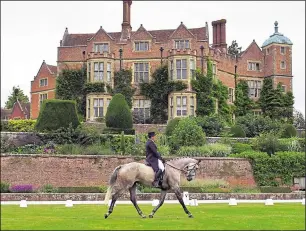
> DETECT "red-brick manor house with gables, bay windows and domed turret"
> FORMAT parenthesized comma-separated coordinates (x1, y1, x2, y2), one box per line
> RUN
(31, 1, 293, 121)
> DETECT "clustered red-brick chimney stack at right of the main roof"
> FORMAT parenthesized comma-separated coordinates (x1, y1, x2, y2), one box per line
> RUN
(211, 19, 227, 51)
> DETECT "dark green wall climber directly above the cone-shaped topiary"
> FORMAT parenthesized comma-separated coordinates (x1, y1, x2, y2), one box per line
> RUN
(112, 69, 136, 108)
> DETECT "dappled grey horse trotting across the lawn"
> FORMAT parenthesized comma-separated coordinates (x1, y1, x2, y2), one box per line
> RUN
(104, 157, 200, 219)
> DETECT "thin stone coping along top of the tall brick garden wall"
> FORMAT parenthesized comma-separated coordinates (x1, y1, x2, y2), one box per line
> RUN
(0, 153, 246, 161)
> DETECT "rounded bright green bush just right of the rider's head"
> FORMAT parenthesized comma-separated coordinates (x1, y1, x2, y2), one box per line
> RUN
(171, 118, 206, 149)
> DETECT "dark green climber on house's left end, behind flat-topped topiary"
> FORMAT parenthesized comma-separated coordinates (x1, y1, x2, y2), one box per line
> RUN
(55, 68, 86, 116)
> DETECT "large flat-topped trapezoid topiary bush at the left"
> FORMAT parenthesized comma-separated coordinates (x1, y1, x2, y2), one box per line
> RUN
(35, 99, 80, 131)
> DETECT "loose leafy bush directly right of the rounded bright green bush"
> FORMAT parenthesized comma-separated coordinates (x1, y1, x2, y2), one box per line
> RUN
(196, 115, 225, 137)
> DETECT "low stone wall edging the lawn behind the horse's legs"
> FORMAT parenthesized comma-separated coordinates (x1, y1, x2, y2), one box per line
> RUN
(1, 192, 305, 201)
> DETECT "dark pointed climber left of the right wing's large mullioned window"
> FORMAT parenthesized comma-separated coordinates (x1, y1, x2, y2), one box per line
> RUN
(234, 80, 253, 116)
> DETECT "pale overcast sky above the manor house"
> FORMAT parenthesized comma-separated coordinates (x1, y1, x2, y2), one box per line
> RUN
(1, 1, 305, 115)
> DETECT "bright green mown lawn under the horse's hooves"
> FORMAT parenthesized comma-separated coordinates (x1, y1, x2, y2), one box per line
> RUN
(1, 203, 305, 230)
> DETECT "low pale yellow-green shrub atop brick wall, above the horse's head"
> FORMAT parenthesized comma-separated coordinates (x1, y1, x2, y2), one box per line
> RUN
(176, 143, 231, 157)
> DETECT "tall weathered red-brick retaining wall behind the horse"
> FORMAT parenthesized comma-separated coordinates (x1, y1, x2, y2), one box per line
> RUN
(1, 154, 256, 187)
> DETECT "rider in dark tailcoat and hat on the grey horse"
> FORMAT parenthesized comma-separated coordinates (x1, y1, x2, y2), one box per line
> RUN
(146, 132, 165, 187)
